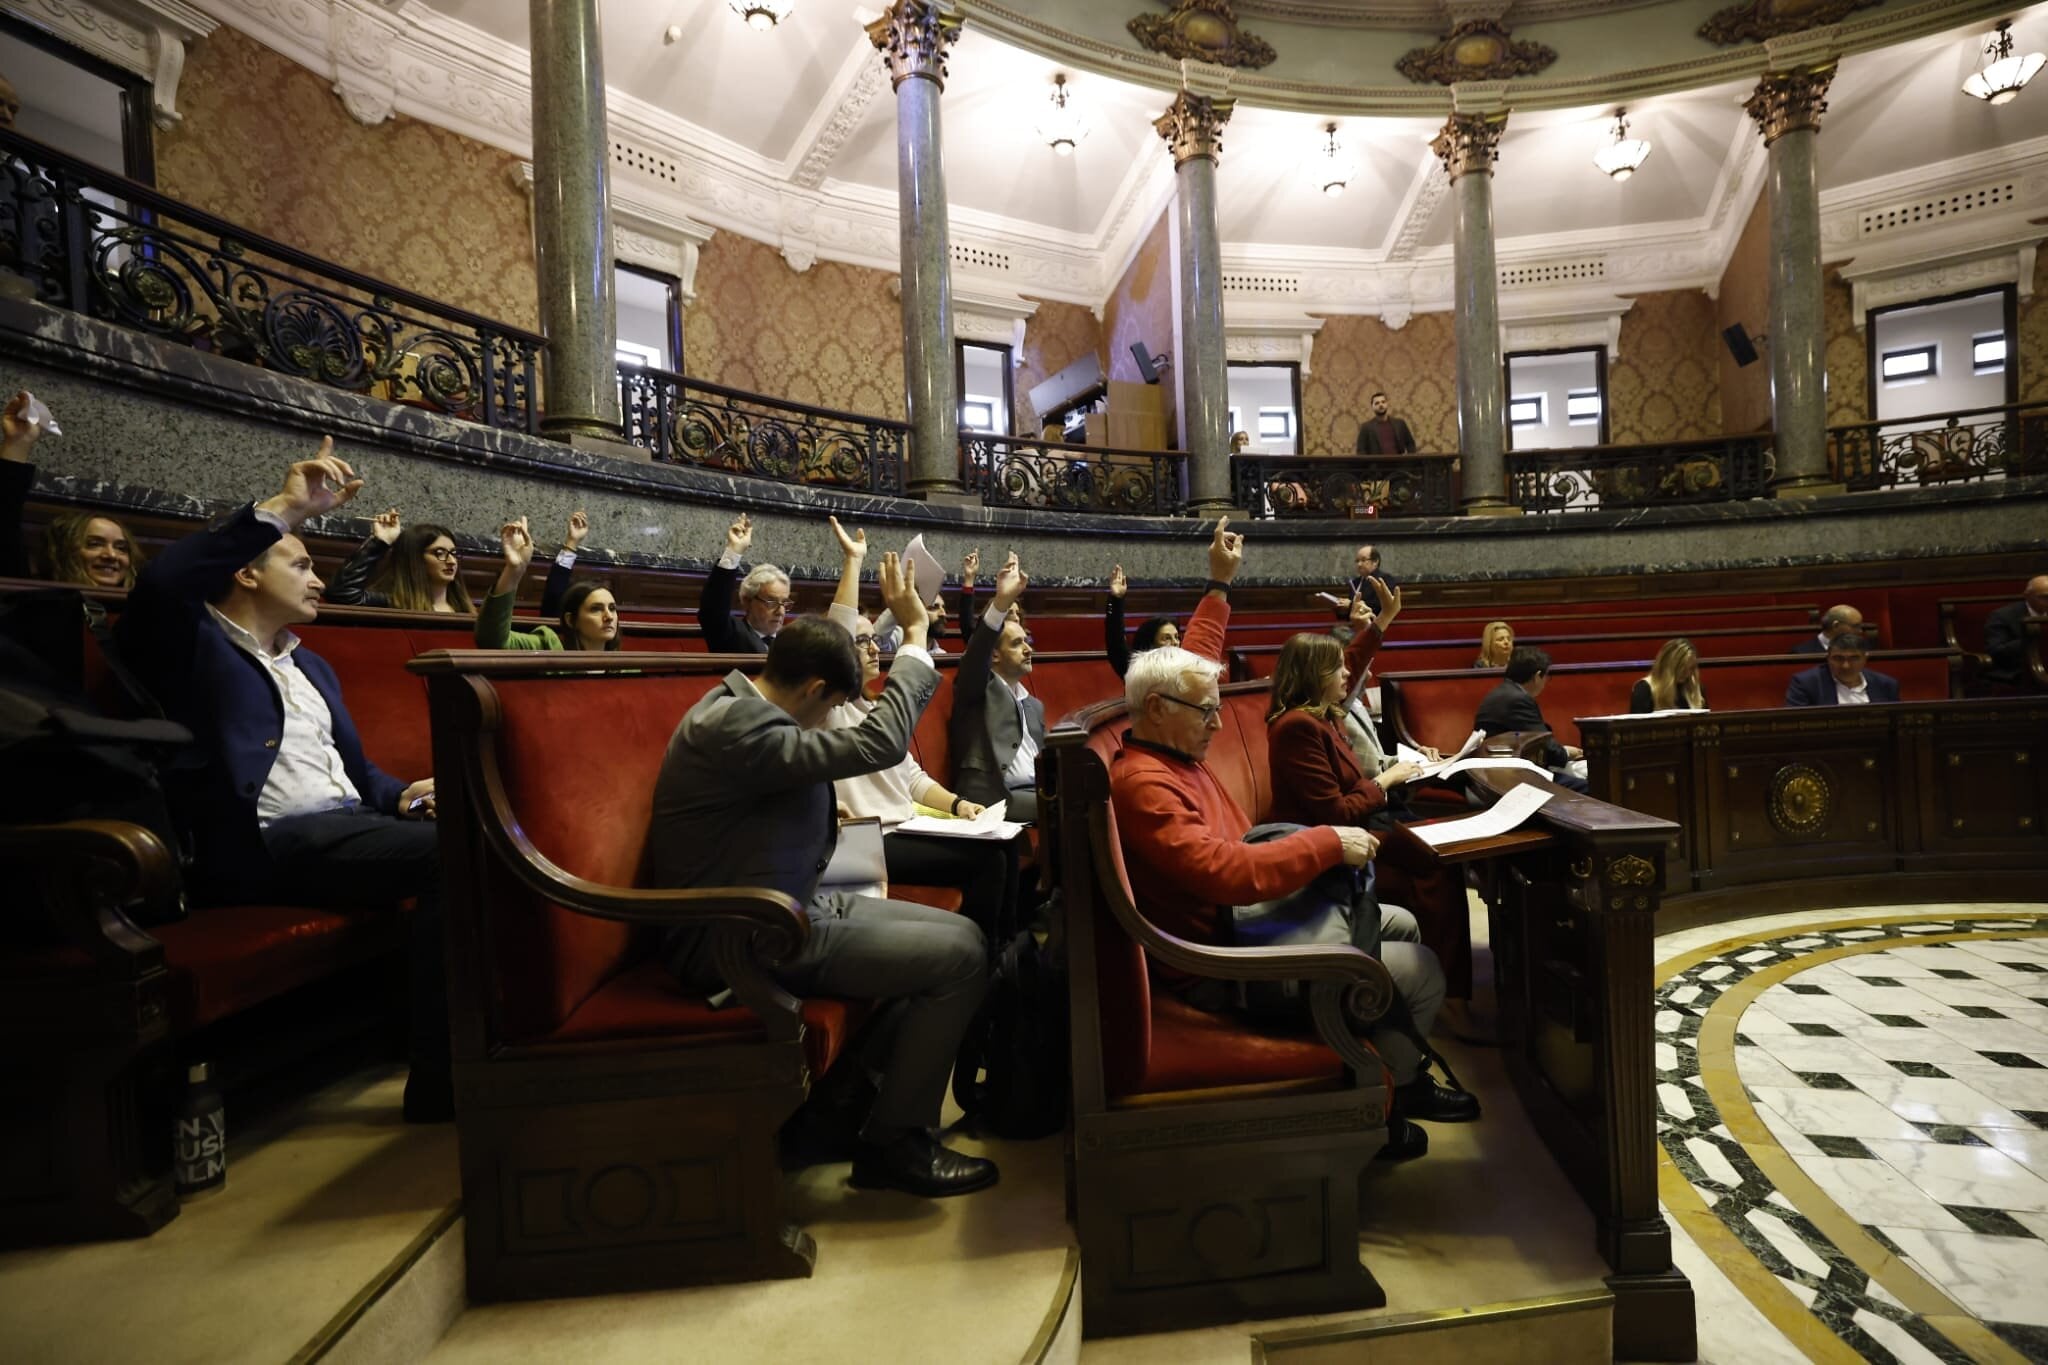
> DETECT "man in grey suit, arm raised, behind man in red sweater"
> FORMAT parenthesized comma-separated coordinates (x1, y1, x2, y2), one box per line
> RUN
(946, 555, 1044, 821)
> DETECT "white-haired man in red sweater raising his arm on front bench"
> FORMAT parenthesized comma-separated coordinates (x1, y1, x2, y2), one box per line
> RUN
(1110, 518, 1479, 1160)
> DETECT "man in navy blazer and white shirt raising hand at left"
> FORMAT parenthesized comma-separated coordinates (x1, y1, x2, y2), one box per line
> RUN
(117, 440, 453, 1119)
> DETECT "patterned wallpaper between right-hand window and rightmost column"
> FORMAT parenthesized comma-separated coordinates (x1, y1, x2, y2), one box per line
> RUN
(1608, 289, 1726, 446)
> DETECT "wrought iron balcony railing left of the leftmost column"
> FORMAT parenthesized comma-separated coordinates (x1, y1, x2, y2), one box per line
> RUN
(0, 131, 543, 432)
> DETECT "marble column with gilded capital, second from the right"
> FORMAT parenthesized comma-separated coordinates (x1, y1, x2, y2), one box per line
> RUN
(1430, 113, 1520, 516)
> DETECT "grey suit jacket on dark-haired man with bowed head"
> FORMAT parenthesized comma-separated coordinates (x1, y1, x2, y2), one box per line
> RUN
(647, 657, 938, 916)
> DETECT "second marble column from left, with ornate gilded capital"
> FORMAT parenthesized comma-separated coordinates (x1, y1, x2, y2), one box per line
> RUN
(868, 0, 963, 499)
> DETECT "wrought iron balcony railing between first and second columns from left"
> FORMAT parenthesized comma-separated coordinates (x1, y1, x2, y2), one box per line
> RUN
(618, 364, 909, 495)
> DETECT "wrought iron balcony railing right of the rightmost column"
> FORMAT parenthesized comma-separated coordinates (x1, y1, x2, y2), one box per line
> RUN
(1827, 403, 2048, 493)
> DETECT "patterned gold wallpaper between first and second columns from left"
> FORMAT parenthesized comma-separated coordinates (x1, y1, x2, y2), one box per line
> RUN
(682, 231, 905, 422)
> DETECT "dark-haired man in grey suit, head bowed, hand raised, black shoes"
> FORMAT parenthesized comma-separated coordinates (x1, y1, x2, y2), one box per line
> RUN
(647, 555, 997, 1197)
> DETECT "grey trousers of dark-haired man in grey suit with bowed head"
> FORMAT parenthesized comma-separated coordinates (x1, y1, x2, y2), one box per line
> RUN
(774, 894, 987, 1138)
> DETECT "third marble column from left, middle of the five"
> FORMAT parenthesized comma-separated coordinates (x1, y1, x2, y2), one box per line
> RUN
(1153, 90, 1235, 516)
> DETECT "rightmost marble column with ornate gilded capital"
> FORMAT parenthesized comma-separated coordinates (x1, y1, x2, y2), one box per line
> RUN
(1743, 63, 1845, 497)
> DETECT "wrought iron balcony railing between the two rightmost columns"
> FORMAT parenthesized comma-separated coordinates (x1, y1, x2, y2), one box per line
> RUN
(1507, 432, 1772, 512)
